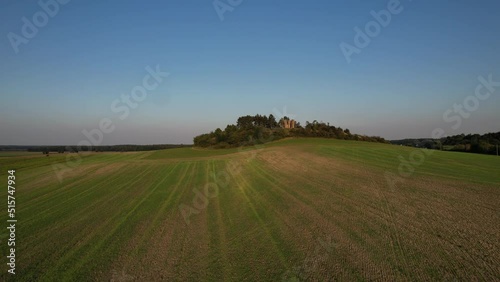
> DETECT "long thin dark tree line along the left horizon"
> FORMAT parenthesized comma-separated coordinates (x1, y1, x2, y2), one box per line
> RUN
(0, 144, 192, 154)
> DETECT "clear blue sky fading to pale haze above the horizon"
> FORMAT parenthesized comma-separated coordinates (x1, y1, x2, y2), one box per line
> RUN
(0, 0, 500, 145)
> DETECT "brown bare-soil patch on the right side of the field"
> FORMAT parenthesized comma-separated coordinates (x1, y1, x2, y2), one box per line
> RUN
(254, 145, 500, 280)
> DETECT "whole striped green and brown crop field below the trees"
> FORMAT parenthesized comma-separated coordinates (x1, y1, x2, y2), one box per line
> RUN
(0, 138, 500, 281)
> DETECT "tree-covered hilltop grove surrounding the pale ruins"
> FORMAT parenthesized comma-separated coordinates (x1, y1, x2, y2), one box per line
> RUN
(194, 114, 389, 148)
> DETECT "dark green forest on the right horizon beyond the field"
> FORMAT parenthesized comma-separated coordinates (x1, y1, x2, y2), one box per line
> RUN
(391, 132, 500, 155)
